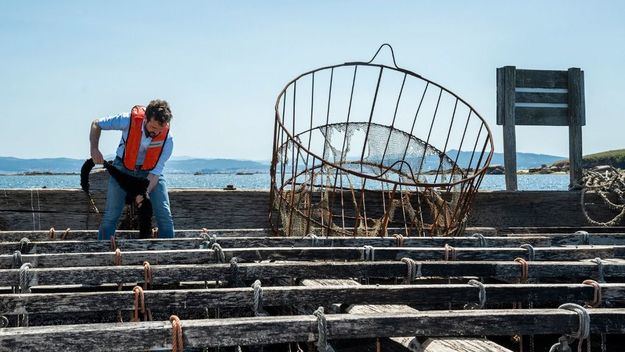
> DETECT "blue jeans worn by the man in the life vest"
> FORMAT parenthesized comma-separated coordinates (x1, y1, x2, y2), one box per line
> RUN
(98, 158, 174, 240)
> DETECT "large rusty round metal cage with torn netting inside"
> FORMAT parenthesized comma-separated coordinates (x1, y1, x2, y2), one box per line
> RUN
(270, 44, 493, 236)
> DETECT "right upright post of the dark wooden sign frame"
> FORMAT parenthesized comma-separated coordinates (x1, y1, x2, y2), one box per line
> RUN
(568, 67, 586, 188)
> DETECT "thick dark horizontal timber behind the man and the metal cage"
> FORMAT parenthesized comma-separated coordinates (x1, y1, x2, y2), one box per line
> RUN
(0, 189, 625, 230)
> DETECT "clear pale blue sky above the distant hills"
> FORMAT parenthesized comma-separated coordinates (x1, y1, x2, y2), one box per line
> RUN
(0, 0, 625, 160)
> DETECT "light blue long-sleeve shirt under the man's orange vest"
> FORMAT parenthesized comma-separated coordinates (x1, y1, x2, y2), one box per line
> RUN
(97, 113, 174, 175)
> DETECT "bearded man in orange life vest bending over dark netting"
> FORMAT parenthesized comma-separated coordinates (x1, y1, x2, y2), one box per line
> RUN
(89, 99, 174, 240)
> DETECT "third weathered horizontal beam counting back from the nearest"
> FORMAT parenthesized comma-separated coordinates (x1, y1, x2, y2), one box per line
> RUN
(0, 260, 625, 290)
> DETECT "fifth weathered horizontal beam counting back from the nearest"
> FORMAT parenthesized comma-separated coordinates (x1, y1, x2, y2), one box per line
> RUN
(0, 236, 552, 254)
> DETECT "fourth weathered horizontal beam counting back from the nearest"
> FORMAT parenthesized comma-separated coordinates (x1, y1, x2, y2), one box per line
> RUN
(0, 246, 625, 269)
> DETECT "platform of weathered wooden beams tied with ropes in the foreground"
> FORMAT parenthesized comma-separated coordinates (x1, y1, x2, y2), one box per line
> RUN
(0, 229, 625, 352)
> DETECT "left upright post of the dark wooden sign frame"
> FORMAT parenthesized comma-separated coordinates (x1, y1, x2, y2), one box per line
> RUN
(497, 66, 518, 191)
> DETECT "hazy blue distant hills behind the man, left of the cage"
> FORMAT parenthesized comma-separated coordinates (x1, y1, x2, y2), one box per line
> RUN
(0, 156, 269, 174)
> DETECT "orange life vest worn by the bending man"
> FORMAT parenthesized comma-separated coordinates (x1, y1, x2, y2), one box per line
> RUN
(123, 105, 169, 171)
